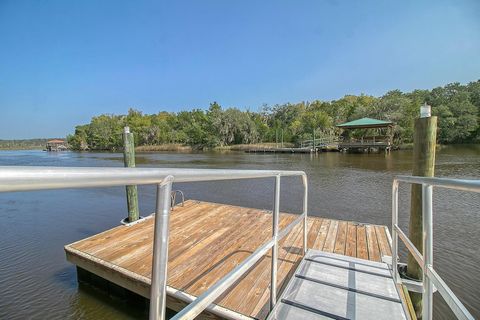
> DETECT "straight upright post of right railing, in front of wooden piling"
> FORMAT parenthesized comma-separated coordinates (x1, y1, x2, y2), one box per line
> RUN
(422, 184, 433, 320)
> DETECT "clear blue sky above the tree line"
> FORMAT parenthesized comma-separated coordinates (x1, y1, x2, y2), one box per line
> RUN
(0, 0, 480, 139)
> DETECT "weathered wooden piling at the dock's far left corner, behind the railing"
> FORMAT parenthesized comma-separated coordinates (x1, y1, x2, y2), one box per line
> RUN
(123, 127, 140, 222)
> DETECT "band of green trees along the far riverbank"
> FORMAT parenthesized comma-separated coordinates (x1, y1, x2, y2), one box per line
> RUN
(68, 80, 480, 150)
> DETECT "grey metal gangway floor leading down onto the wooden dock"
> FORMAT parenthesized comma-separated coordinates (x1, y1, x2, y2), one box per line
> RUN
(267, 249, 409, 320)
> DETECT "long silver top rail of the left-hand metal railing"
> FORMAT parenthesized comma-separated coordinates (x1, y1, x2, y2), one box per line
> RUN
(0, 166, 306, 192)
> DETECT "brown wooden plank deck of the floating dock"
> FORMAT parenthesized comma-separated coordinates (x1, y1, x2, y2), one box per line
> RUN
(65, 200, 391, 319)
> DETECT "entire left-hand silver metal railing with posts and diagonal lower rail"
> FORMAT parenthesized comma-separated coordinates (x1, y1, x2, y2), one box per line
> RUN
(0, 166, 308, 319)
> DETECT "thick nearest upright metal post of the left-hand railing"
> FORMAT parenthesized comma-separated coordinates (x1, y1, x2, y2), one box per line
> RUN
(149, 176, 173, 320)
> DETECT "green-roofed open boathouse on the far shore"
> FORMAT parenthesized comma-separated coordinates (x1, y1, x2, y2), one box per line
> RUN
(336, 118, 394, 152)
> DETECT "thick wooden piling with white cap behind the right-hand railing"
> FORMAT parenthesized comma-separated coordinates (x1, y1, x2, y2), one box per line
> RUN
(407, 106, 437, 320)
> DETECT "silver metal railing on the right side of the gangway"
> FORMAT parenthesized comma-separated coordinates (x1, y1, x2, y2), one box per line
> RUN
(392, 176, 480, 320)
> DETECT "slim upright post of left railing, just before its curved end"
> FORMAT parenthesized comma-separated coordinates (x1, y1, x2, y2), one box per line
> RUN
(270, 175, 280, 310)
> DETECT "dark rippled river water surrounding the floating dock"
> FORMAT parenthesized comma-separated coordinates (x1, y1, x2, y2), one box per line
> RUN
(0, 145, 480, 319)
